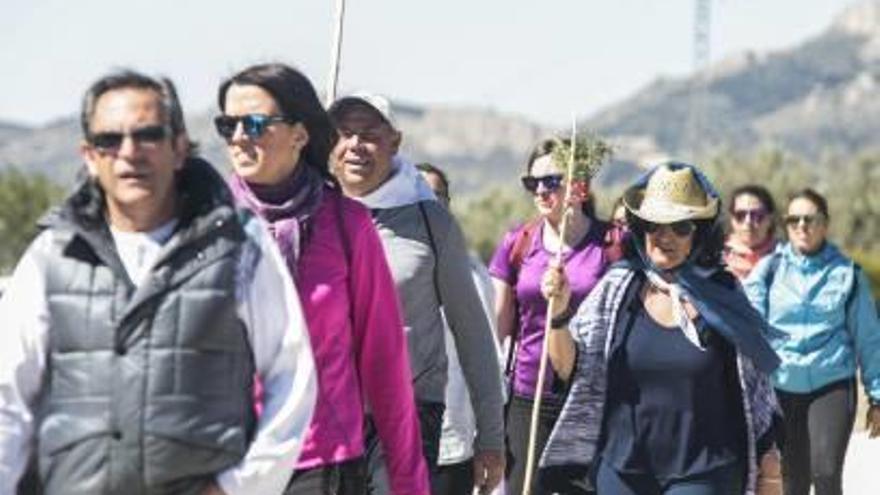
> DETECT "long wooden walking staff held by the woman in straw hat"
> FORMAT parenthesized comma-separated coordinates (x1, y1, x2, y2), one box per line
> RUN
(523, 115, 577, 495)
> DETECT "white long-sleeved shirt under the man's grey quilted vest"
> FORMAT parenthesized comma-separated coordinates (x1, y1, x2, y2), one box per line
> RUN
(0, 217, 317, 495)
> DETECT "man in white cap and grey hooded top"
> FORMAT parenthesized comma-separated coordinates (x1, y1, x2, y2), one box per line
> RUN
(329, 93, 504, 494)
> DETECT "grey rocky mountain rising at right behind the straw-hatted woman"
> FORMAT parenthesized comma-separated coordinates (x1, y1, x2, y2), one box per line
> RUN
(588, 1, 880, 158)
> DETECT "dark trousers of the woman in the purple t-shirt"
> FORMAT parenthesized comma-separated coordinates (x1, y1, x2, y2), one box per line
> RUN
(505, 395, 562, 495)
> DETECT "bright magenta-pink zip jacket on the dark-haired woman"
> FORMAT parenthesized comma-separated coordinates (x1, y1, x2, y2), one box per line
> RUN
(296, 189, 430, 495)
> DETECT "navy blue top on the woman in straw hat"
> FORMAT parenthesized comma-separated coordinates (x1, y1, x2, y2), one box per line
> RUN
(601, 280, 746, 483)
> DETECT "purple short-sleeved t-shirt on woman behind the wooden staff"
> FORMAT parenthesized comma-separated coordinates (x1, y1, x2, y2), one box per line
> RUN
(489, 220, 608, 398)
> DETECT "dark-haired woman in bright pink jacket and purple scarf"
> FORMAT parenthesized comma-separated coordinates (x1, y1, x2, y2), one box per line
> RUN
(215, 64, 430, 495)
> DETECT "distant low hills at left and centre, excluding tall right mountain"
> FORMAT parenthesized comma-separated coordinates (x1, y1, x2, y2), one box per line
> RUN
(0, 105, 547, 191)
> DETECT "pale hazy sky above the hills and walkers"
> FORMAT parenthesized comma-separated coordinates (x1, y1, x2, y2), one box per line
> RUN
(0, 0, 853, 128)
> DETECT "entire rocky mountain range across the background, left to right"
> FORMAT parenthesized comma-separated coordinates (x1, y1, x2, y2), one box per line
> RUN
(0, 0, 880, 193)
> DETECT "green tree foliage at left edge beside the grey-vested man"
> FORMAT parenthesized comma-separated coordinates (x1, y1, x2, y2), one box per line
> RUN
(0, 167, 63, 273)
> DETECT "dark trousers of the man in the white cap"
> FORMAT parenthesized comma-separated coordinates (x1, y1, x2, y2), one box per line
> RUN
(364, 402, 446, 495)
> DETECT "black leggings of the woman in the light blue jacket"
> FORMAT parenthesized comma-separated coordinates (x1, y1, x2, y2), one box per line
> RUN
(776, 378, 857, 495)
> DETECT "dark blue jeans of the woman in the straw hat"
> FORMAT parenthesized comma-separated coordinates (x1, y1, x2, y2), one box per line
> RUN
(596, 462, 743, 495)
